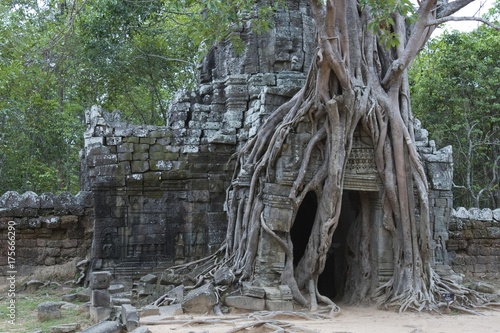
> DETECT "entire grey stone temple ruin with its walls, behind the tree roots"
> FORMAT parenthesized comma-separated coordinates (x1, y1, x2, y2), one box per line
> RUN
(0, 0, 500, 314)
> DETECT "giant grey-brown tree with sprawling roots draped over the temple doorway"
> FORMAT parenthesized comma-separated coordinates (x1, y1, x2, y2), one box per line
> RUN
(170, 0, 486, 310)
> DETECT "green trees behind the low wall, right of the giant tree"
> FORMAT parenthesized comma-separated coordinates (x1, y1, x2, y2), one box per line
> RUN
(411, 27, 500, 208)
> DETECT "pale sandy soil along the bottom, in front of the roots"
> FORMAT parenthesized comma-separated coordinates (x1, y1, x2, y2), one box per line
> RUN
(143, 306, 500, 333)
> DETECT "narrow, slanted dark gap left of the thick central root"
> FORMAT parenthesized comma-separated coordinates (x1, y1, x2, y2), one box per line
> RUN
(290, 192, 318, 266)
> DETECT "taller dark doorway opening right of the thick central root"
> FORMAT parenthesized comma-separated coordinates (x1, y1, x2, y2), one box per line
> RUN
(318, 190, 360, 301)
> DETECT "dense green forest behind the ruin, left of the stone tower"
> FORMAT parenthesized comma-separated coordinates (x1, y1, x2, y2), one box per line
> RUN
(0, 0, 284, 193)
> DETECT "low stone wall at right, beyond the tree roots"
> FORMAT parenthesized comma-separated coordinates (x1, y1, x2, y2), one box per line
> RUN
(447, 207, 500, 278)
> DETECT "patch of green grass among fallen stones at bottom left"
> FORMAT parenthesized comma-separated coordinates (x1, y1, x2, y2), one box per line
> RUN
(0, 287, 91, 333)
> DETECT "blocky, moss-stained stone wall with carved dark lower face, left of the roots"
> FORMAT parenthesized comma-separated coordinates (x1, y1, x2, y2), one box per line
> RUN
(83, 107, 233, 276)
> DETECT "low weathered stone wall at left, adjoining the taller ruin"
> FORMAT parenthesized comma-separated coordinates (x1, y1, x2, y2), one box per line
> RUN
(0, 191, 94, 277)
